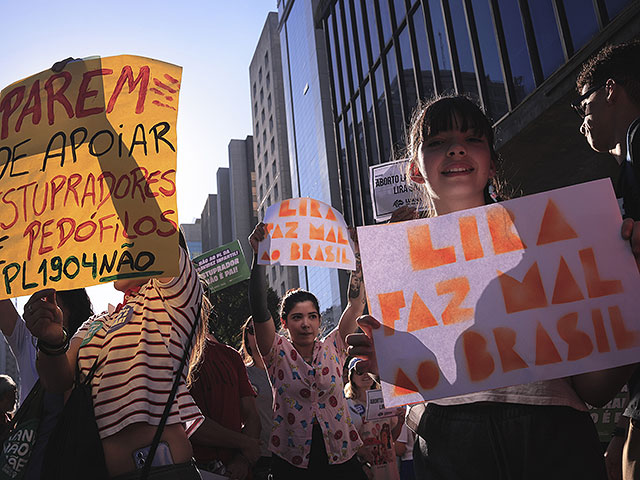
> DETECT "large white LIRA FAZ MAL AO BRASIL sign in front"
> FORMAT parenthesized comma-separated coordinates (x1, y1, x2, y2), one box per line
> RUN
(358, 179, 640, 407)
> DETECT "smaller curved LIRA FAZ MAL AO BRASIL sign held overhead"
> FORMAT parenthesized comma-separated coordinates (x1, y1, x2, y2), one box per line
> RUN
(258, 198, 356, 270)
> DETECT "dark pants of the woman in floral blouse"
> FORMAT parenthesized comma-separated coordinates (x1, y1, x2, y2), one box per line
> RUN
(271, 424, 367, 480)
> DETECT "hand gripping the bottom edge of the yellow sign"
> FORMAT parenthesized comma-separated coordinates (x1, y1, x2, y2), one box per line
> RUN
(23, 288, 64, 345)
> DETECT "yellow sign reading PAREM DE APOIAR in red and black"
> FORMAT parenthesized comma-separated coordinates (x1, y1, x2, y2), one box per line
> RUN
(0, 56, 182, 299)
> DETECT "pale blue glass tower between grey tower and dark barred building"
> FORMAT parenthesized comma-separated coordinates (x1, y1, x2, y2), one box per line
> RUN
(278, 0, 346, 327)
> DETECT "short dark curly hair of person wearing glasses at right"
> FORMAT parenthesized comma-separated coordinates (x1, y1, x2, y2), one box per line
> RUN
(576, 40, 640, 107)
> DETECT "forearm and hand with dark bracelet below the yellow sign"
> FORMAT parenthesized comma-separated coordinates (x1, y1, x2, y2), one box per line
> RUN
(23, 288, 77, 393)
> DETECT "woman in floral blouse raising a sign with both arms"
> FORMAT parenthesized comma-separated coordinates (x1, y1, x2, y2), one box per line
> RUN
(249, 223, 366, 480)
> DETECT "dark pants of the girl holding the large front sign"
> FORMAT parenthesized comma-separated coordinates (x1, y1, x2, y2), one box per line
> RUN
(413, 403, 607, 480)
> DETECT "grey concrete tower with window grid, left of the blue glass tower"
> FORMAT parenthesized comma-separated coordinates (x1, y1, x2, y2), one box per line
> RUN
(249, 12, 300, 296)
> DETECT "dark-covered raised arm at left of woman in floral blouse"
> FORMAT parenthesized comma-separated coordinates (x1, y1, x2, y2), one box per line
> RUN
(249, 223, 276, 357)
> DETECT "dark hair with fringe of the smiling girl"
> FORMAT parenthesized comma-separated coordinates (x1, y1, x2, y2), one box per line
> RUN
(407, 95, 509, 216)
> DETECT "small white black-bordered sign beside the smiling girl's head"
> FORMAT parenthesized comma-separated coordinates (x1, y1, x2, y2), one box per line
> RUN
(369, 160, 418, 222)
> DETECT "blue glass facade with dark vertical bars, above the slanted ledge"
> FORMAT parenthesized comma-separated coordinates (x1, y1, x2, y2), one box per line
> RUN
(318, 0, 637, 225)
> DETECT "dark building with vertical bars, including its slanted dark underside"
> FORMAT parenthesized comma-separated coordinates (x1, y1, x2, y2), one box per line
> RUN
(316, 0, 640, 225)
